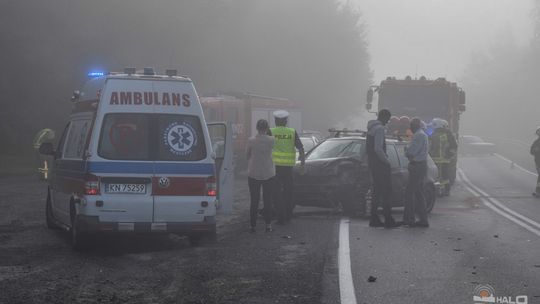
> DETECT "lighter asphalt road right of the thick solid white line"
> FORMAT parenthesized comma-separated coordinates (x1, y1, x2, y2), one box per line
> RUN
(344, 156, 540, 303)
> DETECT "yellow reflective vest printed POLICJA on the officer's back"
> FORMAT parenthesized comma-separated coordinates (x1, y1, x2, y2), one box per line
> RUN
(270, 127, 296, 167)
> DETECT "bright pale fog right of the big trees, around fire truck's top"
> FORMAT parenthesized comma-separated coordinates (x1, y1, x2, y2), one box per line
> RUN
(350, 0, 540, 141)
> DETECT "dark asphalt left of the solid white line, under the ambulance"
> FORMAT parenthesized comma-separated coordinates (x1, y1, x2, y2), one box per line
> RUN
(0, 176, 339, 304)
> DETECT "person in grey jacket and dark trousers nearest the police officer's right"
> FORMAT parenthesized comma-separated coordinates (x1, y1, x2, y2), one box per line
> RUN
(366, 109, 398, 228)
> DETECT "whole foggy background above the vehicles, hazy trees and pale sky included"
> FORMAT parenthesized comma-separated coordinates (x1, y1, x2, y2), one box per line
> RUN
(0, 0, 540, 157)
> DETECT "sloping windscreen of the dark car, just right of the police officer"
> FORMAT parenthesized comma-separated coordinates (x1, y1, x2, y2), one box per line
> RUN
(307, 140, 365, 159)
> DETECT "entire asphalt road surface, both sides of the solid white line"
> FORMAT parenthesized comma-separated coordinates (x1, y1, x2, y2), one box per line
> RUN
(0, 146, 540, 304)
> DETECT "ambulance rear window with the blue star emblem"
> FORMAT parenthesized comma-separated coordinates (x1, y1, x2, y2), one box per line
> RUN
(98, 113, 206, 161)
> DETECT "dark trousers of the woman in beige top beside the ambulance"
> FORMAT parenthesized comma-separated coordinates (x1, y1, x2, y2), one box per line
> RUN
(248, 177, 274, 227)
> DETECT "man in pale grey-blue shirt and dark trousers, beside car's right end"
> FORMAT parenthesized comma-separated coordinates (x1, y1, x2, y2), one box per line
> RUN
(403, 118, 429, 227)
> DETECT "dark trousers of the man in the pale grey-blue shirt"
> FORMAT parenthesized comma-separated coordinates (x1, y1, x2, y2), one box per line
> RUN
(403, 161, 427, 224)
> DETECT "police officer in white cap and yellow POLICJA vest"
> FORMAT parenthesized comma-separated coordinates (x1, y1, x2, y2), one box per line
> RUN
(270, 110, 305, 225)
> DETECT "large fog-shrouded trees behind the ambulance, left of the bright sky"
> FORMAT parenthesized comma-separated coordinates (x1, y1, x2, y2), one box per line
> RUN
(0, 0, 371, 153)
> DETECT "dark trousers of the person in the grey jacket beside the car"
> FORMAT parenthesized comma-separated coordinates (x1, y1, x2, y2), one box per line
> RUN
(370, 164, 392, 219)
